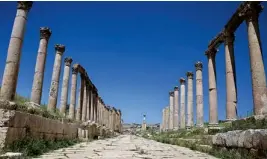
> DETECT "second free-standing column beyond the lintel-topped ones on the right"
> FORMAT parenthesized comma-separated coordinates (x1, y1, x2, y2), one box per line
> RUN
(186, 72, 194, 129)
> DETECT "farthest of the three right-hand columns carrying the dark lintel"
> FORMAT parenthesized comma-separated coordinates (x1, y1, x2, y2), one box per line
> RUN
(206, 49, 218, 127)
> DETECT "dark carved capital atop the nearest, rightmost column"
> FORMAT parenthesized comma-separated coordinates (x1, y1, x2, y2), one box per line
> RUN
(239, 2, 263, 21)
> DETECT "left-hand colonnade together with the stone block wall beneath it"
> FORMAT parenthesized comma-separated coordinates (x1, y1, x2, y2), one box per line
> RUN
(0, 1, 122, 152)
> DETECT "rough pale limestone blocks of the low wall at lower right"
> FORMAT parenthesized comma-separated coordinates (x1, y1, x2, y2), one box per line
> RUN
(212, 129, 267, 150)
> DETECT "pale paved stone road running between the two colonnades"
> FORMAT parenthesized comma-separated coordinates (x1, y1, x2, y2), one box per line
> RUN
(34, 135, 218, 159)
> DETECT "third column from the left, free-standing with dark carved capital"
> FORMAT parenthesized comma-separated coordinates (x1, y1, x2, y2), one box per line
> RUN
(47, 44, 65, 111)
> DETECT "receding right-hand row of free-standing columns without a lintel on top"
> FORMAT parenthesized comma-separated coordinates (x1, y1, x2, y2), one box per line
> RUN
(161, 62, 204, 131)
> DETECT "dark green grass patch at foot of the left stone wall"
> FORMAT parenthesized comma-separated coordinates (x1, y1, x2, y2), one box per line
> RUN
(5, 138, 80, 157)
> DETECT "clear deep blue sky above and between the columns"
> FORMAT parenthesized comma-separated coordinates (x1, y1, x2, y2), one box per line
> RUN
(0, 2, 267, 123)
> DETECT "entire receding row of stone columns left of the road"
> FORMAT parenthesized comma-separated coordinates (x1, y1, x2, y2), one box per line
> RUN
(0, 1, 121, 132)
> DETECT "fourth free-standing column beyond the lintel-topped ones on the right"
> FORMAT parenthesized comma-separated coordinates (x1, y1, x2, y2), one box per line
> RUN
(173, 86, 179, 130)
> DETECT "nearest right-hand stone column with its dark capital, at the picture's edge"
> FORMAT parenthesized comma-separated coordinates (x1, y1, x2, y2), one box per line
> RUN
(241, 4, 267, 115)
